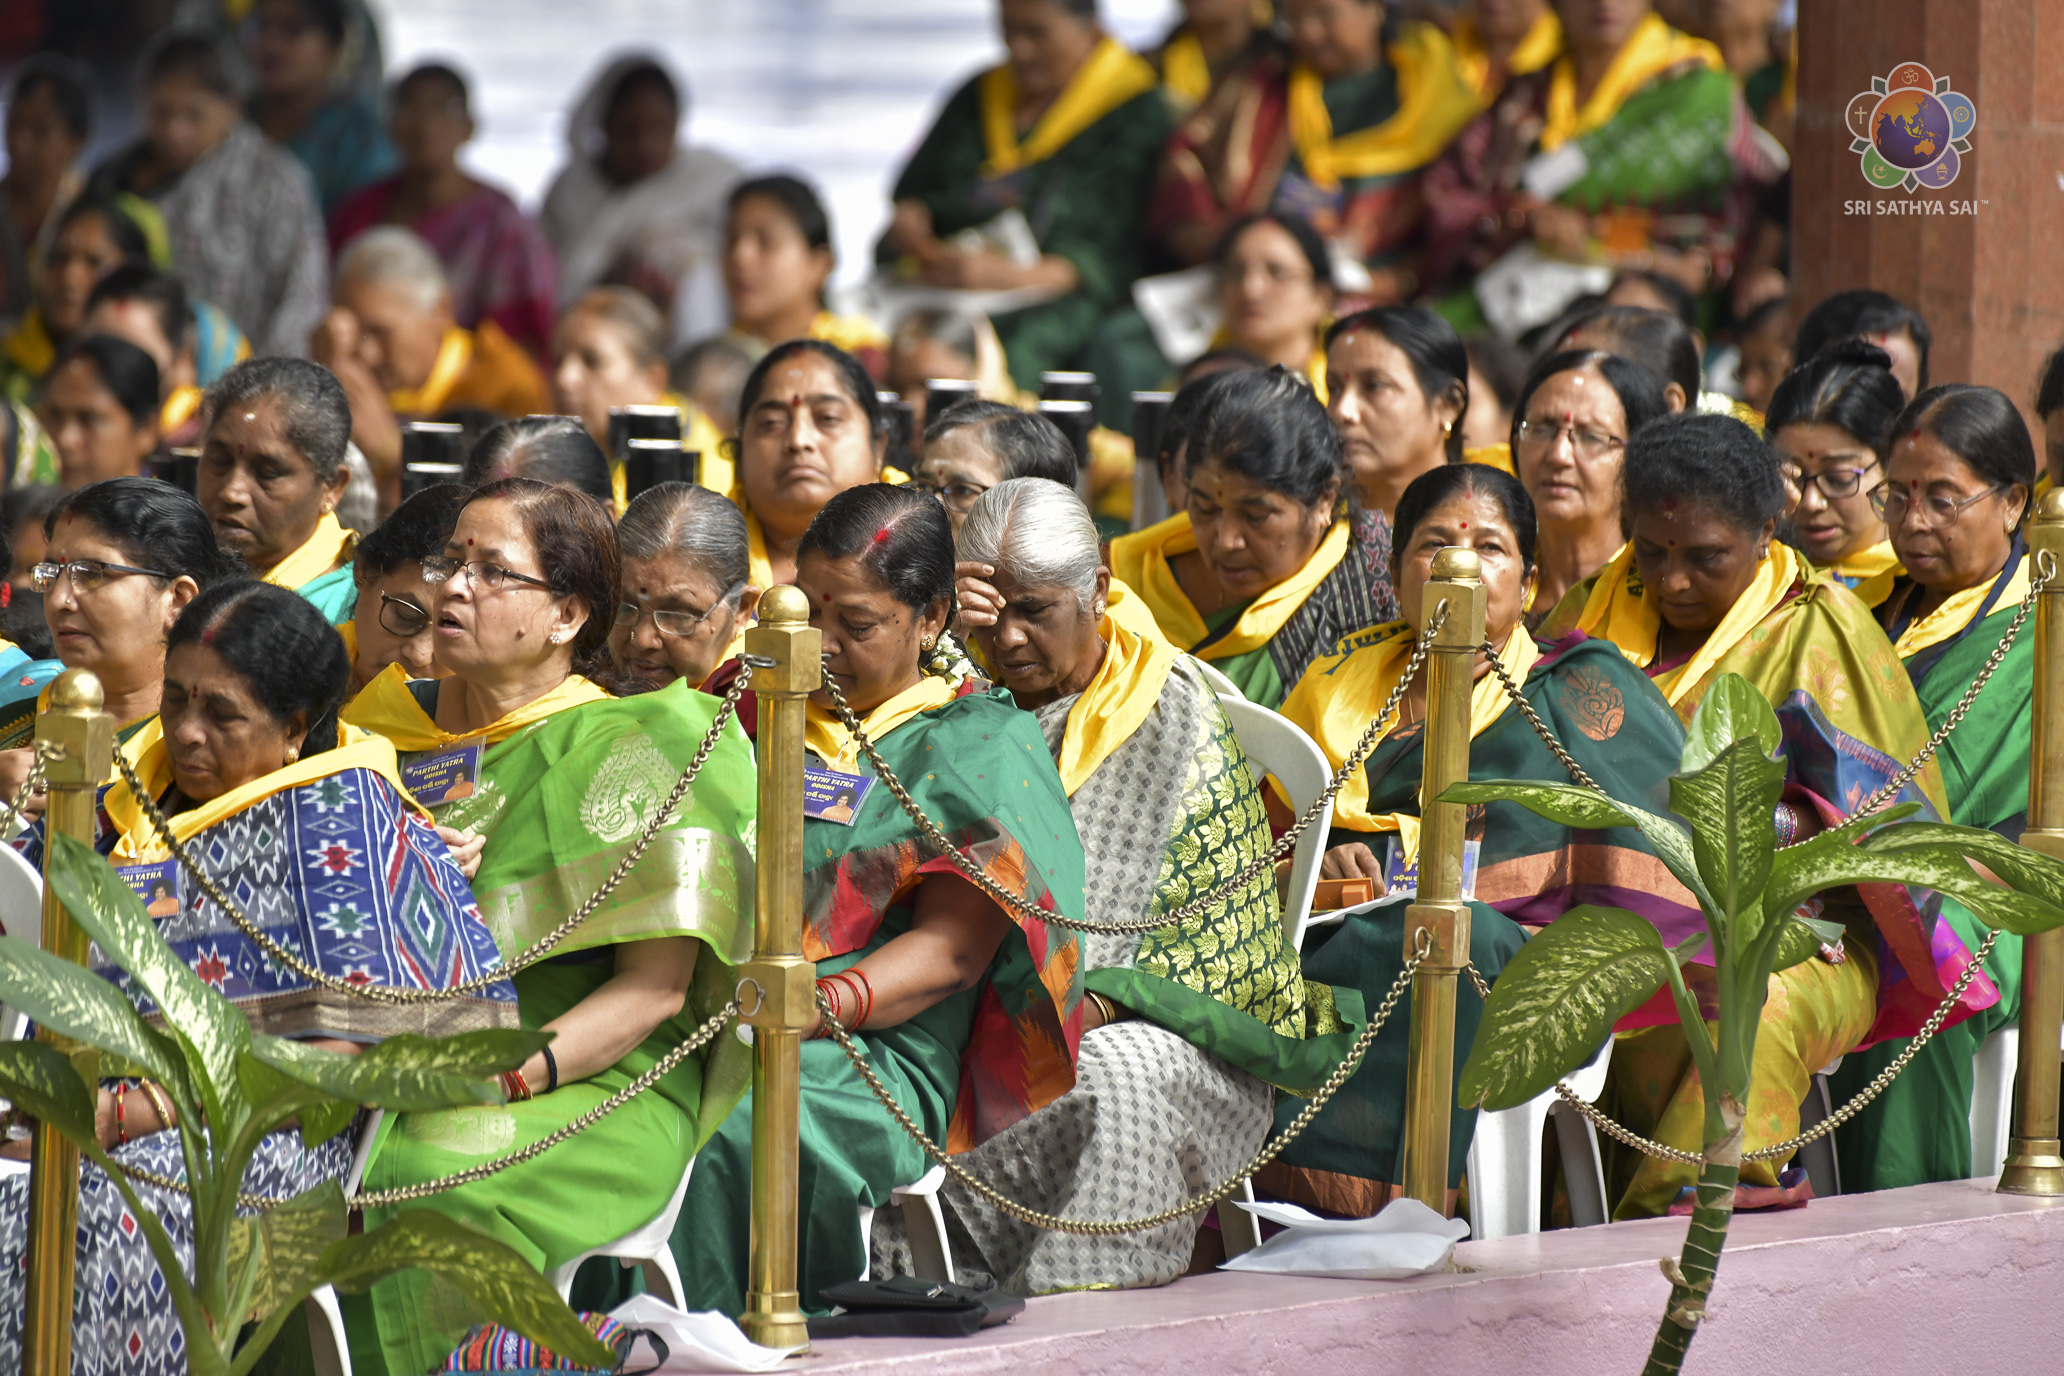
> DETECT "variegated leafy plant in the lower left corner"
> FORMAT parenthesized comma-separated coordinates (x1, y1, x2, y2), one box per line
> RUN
(0, 836, 615, 1376)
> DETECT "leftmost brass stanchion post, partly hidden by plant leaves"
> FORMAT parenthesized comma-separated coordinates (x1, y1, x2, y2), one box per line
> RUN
(21, 668, 116, 1376)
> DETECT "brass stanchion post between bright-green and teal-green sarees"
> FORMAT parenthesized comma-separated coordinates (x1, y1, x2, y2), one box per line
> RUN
(739, 586, 824, 1347)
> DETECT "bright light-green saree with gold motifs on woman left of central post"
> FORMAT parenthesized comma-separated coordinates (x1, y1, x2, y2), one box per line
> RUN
(347, 683, 757, 1376)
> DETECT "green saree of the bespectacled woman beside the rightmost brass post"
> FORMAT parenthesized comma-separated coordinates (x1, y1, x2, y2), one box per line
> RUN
(1829, 559, 2035, 1190)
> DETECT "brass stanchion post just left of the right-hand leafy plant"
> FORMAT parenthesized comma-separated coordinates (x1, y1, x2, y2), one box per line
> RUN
(1404, 549, 1486, 1213)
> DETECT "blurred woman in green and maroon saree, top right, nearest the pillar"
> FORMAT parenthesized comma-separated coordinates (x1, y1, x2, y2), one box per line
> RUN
(1424, 0, 1787, 309)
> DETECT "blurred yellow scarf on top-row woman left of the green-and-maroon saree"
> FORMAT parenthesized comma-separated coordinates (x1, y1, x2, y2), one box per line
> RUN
(1290, 23, 1478, 192)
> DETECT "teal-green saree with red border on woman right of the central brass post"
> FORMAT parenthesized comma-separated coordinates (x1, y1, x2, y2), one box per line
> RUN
(673, 685, 1084, 1314)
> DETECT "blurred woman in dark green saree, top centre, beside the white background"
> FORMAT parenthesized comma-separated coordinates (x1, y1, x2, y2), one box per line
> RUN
(875, 0, 1168, 392)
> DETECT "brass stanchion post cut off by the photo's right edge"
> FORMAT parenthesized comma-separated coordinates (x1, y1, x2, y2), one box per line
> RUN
(1979, 491, 2064, 1194)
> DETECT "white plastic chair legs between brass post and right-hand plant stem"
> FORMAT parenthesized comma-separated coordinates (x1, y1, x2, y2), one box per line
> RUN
(1470, 1036, 1612, 1242)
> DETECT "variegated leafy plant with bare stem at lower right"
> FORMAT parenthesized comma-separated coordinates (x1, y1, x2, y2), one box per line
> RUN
(1441, 675, 2064, 1376)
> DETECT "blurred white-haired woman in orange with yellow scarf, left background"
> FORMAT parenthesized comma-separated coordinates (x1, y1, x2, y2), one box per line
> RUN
(310, 225, 551, 507)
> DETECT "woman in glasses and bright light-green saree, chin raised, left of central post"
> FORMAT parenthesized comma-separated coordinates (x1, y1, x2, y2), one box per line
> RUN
(345, 479, 763, 1372)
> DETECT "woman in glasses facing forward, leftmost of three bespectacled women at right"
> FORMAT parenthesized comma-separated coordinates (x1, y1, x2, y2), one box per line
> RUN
(1511, 349, 1664, 625)
